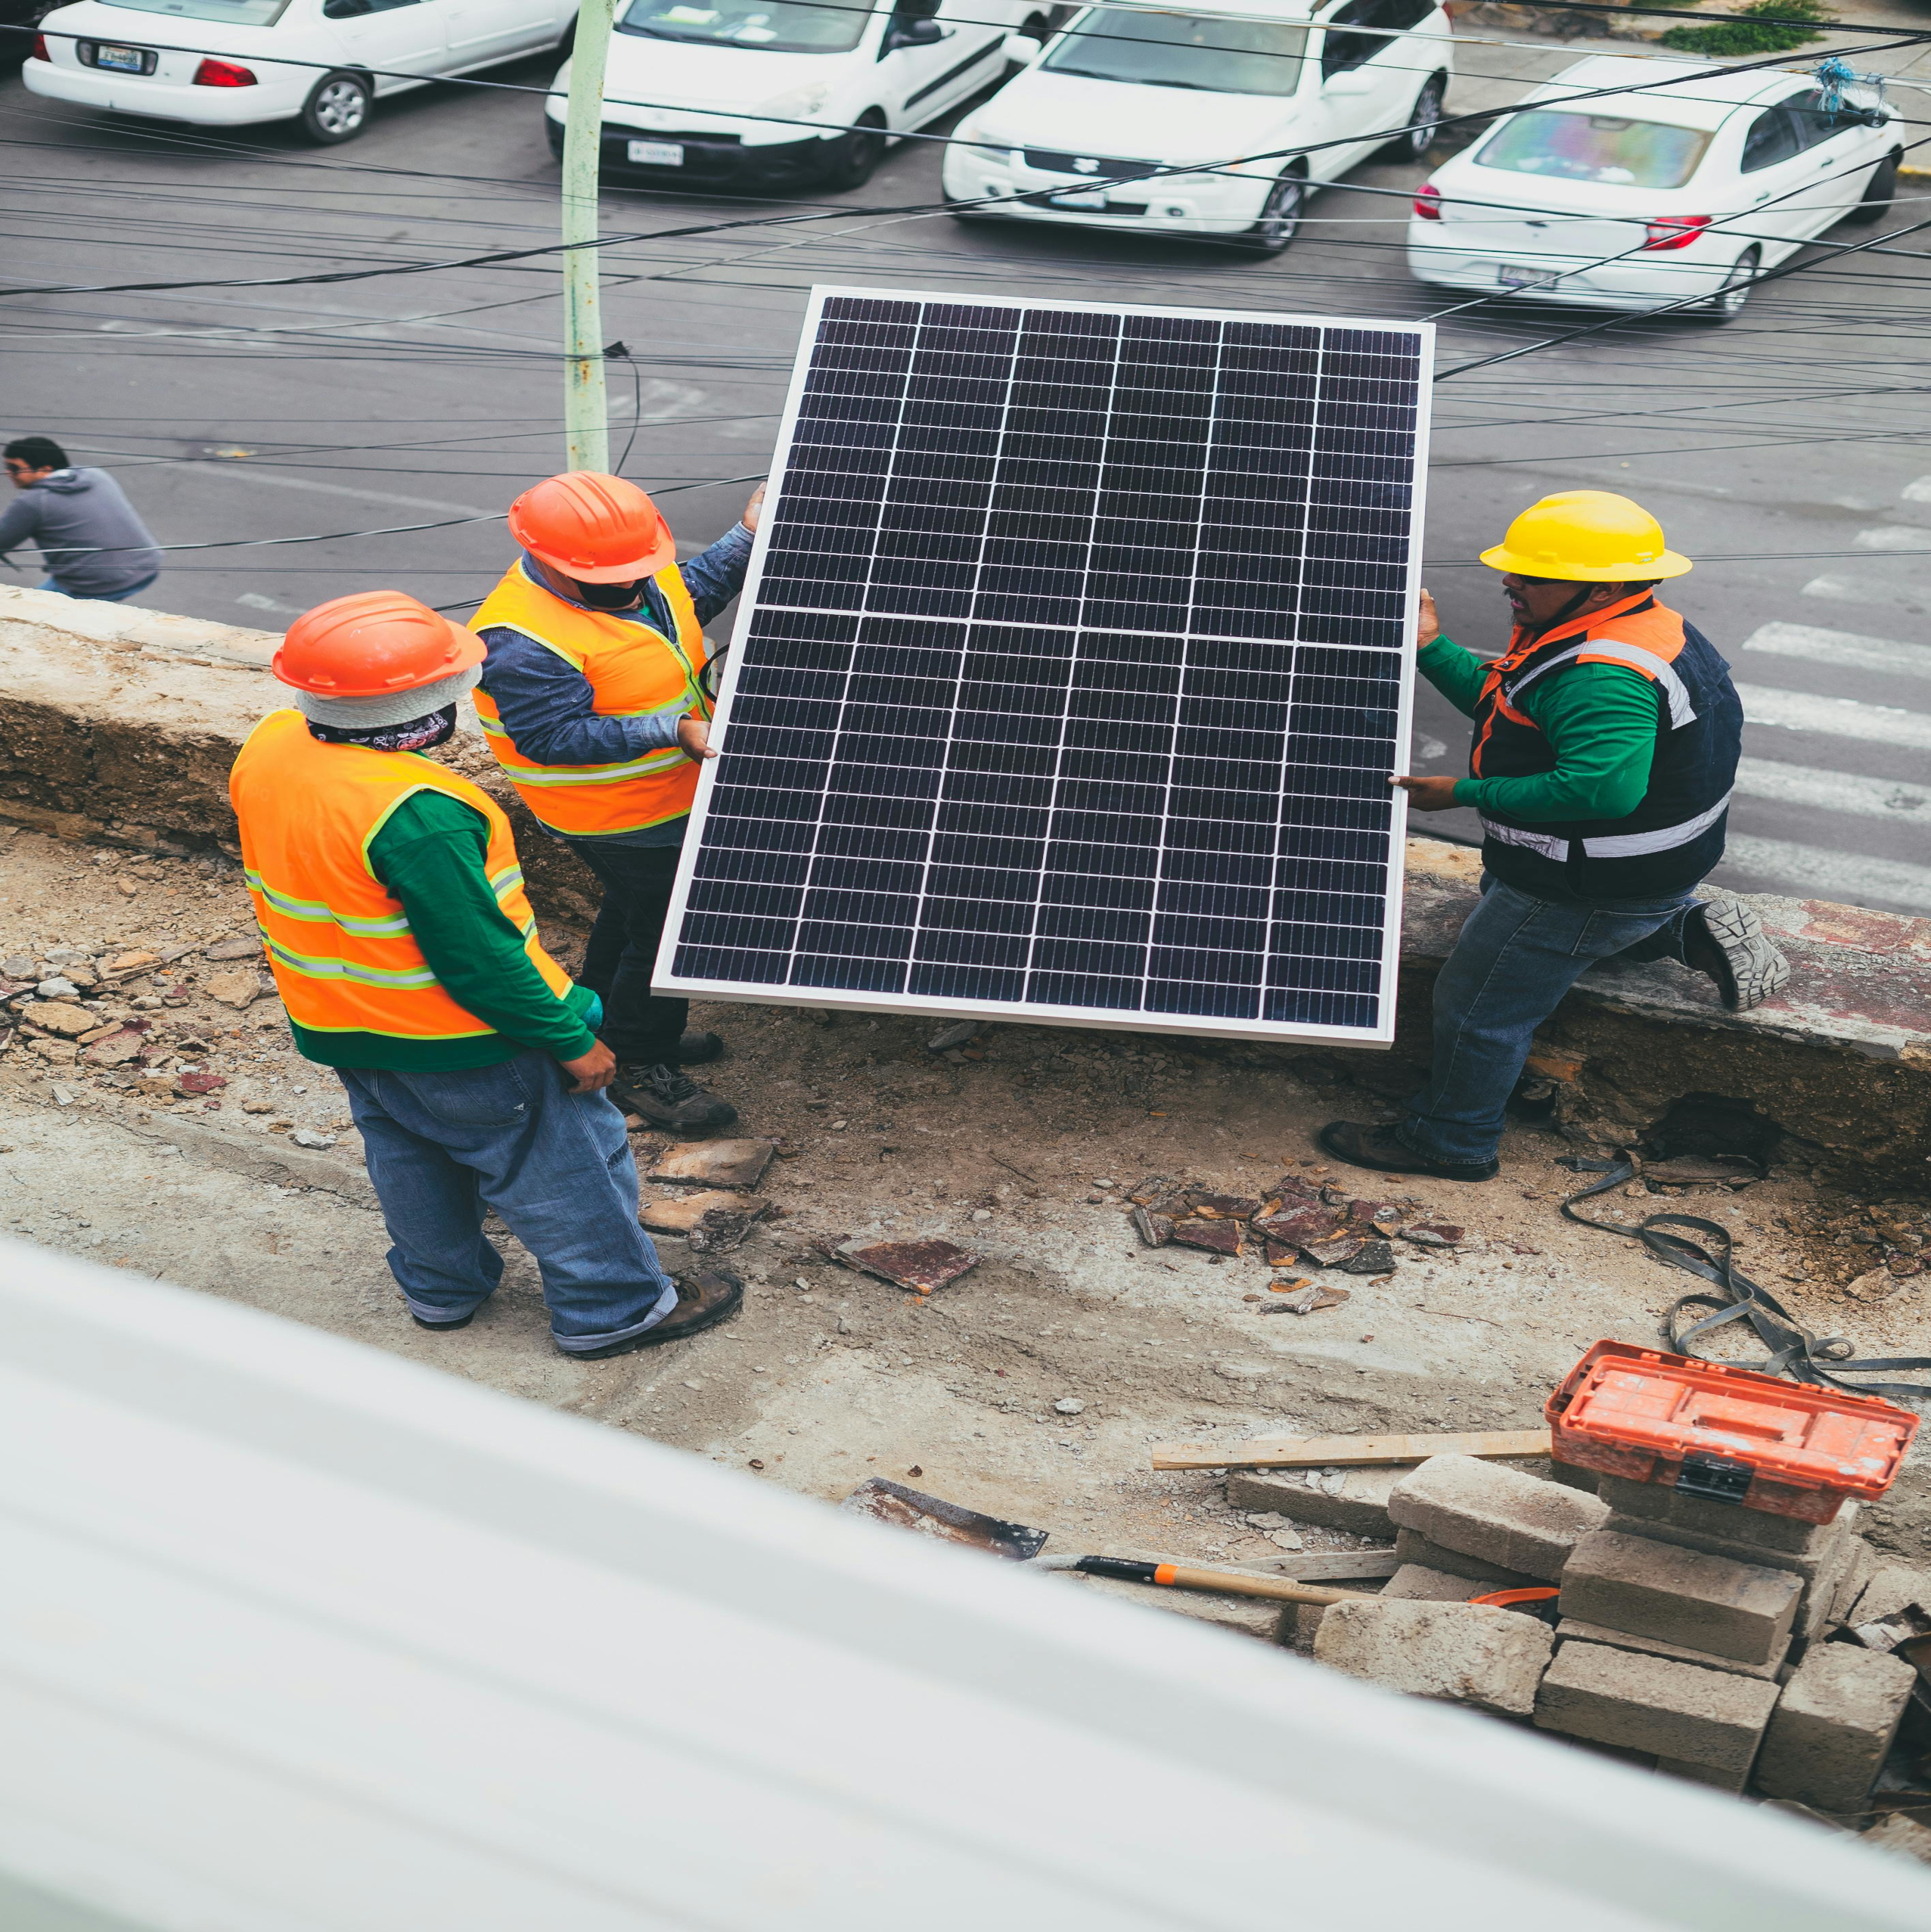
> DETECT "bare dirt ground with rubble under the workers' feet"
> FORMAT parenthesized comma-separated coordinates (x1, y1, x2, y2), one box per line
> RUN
(0, 827, 1931, 1594)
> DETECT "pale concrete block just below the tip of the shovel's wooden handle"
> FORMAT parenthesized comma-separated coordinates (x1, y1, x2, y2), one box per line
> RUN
(1315, 1598, 1554, 1718)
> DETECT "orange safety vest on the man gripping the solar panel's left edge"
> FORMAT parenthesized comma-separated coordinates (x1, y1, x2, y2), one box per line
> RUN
(469, 558, 711, 838)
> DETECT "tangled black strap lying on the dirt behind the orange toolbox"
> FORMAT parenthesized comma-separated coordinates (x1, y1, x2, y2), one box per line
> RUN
(1562, 1154, 1931, 1402)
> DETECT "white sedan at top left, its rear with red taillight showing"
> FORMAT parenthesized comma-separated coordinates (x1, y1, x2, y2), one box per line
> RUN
(21, 0, 576, 143)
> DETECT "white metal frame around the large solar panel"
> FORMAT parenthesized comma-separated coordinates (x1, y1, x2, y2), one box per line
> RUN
(653, 286, 1435, 1047)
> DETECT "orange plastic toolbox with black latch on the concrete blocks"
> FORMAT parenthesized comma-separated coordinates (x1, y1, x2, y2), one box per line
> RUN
(1543, 1340, 1917, 1523)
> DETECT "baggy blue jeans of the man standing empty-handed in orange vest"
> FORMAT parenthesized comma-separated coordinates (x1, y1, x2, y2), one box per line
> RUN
(336, 1053, 678, 1354)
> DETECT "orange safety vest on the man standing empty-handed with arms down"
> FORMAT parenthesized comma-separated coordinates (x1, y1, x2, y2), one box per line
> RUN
(228, 711, 570, 1039)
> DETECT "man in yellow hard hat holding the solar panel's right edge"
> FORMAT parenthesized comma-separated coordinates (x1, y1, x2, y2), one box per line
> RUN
(1321, 489, 1790, 1180)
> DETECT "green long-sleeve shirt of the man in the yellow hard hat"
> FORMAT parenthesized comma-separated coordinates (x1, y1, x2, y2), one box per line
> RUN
(1415, 638, 1656, 821)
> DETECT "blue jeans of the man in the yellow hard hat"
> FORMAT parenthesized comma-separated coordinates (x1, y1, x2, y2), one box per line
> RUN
(1400, 873, 1697, 1161)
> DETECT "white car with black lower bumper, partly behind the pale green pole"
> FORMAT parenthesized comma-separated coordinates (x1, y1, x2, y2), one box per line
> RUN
(546, 0, 1064, 188)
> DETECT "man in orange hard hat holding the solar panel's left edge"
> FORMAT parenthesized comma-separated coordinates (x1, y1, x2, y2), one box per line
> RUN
(469, 470, 765, 1138)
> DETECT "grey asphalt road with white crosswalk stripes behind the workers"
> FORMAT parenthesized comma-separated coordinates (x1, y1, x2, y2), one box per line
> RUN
(0, 28, 1931, 914)
